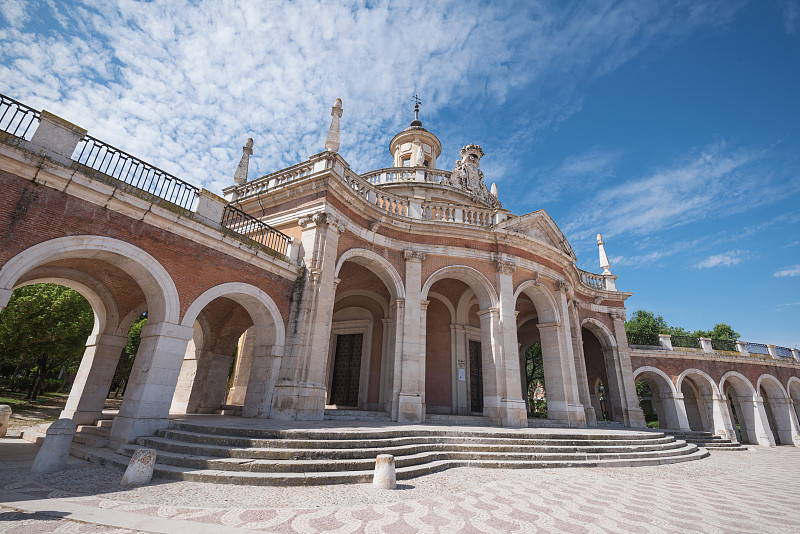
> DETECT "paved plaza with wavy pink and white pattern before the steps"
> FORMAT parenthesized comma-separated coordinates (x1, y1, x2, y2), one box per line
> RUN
(0, 439, 800, 534)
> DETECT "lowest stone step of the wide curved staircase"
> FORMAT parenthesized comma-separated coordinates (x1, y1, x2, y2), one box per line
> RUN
(103, 445, 709, 486)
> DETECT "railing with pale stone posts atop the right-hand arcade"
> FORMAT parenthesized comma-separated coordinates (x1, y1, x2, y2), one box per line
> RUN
(628, 334, 800, 363)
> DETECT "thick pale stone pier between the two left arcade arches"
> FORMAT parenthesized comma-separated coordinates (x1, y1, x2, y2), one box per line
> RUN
(110, 323, 194, 448)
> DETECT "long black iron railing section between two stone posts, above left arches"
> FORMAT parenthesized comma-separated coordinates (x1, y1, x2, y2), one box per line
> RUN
(73, 135, 199, 210)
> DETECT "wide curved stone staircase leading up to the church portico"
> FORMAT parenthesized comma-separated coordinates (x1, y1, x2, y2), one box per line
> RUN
(102, 422, 708, 486)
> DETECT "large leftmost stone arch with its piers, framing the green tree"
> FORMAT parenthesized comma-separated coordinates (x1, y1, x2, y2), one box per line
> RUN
(0, 236, 179, 443)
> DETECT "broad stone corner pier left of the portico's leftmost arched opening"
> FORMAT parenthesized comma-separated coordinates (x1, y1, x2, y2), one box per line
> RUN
(272, 212, 344, 421)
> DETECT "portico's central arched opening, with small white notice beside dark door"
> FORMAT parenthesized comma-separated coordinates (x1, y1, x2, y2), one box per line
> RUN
(422, 267, 500, 419)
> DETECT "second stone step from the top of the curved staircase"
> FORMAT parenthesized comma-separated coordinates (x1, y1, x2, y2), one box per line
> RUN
(137, 432, 684, 460)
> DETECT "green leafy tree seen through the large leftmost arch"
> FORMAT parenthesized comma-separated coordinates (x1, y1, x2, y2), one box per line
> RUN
(0, 284, 94, 399)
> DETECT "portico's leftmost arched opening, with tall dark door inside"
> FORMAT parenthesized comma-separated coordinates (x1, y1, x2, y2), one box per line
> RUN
(326, 249, 403, 412)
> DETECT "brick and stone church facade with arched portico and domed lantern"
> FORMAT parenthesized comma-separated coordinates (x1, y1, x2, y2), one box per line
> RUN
(215, 101, 644, 434)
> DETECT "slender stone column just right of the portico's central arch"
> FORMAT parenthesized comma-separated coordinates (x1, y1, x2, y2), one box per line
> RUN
(494, 260, 528, 427)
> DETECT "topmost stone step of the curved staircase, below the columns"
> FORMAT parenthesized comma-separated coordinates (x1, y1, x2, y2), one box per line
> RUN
(157, 425, 676, 450)
